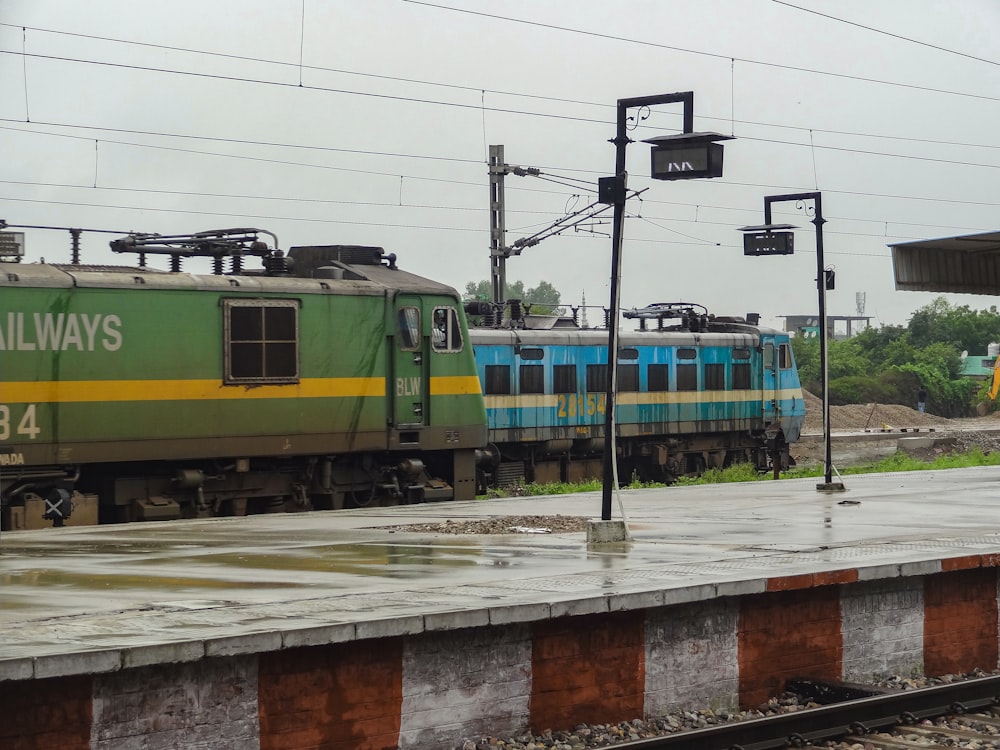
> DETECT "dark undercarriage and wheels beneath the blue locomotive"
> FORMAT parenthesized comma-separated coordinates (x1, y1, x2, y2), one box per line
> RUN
(481, 430, 794, 489)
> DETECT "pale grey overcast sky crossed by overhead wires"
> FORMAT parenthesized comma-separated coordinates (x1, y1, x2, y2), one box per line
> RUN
(0, 0, 1000, 325)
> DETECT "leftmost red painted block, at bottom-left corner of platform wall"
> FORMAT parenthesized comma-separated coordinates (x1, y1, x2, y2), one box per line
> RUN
(0, 675, 94, 750)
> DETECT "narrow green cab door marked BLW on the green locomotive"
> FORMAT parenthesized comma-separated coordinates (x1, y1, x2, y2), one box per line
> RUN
(389, 295, 428, 428)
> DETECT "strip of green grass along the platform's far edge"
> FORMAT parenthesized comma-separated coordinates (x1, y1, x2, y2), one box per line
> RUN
(480, 447, 1000, 498)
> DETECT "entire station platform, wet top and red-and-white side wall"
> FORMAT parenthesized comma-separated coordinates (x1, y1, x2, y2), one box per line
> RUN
(0, 468, 1000, 748)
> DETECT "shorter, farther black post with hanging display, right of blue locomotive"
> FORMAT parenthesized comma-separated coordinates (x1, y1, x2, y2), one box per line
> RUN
(740, 192, 844, 492)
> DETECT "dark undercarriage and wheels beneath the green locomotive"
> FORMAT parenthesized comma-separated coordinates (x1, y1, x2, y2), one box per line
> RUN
(2, 450, 484, 530)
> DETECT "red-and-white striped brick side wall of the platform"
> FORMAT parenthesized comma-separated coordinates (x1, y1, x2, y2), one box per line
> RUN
(0, 568, 1000, 750)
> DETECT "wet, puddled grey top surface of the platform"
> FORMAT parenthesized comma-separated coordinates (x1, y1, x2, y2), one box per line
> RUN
(0, 467, 1000, 679)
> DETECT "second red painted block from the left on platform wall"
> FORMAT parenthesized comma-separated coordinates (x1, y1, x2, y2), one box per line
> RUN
(258, 638, 403, 750)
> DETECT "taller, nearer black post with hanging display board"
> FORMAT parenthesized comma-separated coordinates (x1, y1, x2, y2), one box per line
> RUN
(598, 91, 731, 521)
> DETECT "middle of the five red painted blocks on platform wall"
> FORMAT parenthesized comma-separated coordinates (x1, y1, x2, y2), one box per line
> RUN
(530, 612, 646, 732)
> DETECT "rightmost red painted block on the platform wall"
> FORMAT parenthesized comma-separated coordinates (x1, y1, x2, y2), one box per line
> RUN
(924, 568, 998, 675)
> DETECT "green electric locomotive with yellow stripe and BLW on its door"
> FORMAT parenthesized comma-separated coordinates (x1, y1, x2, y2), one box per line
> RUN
(0, 230, 486, 528)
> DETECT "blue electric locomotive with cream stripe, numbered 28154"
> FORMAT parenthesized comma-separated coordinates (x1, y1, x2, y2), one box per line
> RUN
(471, 303, 805, 484)
